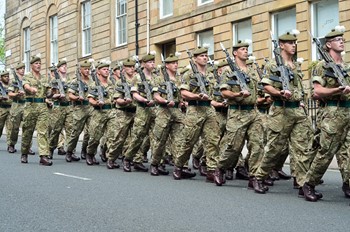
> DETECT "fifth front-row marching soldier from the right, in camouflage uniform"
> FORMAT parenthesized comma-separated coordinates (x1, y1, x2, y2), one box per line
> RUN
(151, 54, 184, 176)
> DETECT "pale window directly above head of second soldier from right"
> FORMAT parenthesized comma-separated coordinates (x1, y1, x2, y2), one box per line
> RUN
(271, 8, 297, 39)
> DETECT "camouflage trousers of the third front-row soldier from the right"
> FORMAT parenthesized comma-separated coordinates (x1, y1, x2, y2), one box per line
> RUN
(218, 109, 264, 176)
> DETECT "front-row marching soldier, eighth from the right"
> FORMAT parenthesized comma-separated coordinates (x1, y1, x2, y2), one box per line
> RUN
(86, 61, 115, 165)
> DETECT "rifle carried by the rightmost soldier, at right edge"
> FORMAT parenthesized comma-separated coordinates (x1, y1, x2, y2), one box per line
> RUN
(309, 32, 349, 87)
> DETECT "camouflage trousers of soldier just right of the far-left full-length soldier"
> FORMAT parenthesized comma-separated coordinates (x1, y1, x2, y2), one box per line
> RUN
(49, 106, 73, 151)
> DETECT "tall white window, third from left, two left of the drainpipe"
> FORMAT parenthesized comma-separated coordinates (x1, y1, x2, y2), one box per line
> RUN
(81, 1, 91, 56)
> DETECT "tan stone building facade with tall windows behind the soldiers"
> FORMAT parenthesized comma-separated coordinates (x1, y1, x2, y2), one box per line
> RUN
(5, 0, 350, 89)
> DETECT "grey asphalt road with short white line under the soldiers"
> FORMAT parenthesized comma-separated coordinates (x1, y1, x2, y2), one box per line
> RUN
(0, 136, 350, 232)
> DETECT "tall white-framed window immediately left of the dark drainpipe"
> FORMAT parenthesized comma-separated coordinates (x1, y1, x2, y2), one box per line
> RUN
(115, 0, 128, 46)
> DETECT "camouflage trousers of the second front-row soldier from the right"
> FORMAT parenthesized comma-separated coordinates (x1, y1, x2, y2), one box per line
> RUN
(255, 106, 314, 185)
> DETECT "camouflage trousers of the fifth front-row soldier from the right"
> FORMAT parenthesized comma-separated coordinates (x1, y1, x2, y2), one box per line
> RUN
(151, 107, 185, 165)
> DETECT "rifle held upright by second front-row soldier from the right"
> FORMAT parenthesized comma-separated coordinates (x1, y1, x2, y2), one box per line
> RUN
(270, 32, 293, 91)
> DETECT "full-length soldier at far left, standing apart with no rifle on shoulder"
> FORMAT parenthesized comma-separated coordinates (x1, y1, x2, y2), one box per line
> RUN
(21, 56, 53, 166)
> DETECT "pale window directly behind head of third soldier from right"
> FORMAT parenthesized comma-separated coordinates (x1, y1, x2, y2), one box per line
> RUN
(232, 19, 253, 53)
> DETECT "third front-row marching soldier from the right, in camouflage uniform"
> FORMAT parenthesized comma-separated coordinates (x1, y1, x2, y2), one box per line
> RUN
(215, 41, 264, 186)
